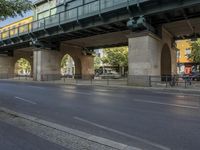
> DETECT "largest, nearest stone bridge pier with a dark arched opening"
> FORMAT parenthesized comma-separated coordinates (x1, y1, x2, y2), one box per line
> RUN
(128, 29, 176, 86)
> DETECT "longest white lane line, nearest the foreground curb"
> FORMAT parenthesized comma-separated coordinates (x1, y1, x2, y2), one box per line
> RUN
(74, 117, 170, 150)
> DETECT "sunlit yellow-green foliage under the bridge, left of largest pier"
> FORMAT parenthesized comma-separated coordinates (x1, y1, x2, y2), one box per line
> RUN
(102, 47, 128, 66)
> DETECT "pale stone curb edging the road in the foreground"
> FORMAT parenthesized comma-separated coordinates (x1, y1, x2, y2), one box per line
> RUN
(0, 107, 142, 150)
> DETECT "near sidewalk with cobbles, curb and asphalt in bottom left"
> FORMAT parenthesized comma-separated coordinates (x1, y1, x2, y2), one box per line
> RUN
(0, 107, 141, 150)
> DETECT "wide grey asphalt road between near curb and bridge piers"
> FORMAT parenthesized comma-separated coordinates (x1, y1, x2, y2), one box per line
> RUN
(0, 81, 200, 150)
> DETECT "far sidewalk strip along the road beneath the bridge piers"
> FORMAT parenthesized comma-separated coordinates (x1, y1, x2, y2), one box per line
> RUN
(0, 79, 200, 93)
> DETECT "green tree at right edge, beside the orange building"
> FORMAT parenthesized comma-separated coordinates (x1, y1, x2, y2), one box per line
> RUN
(188, 39, 200, 71)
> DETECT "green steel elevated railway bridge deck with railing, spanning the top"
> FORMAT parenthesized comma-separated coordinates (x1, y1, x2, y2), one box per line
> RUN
(0, 0, 200, 53)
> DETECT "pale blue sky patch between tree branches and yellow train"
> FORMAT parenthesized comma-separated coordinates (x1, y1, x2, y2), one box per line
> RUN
(0, 0, 36, 27)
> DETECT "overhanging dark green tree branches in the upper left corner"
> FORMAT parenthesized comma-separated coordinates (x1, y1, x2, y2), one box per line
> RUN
(0, 0, 32, 20)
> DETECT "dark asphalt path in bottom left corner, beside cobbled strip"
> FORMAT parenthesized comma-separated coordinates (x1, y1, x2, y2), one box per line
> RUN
(0, 121, 66, 150)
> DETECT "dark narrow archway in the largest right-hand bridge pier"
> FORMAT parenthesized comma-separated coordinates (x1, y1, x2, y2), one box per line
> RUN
(160, 44, 172, 76)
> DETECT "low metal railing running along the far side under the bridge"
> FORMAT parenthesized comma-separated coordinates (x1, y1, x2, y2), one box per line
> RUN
(0, 74, 200, 88)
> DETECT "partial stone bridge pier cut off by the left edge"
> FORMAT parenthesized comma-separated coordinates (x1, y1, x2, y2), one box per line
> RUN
(0, 55, 14, 79)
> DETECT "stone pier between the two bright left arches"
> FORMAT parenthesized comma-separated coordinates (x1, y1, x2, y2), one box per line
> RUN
(33, 49, 60, 81)
